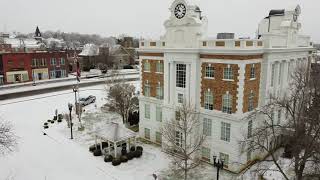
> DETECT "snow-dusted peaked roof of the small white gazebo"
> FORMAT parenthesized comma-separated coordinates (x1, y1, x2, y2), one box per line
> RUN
(94, 122, 136, 142)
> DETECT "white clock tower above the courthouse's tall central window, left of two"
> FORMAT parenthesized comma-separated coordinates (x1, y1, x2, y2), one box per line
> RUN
(164, 0, 208, 48)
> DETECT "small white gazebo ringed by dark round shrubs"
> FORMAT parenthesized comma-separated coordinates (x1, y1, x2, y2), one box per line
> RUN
(94, 122, 136, 158)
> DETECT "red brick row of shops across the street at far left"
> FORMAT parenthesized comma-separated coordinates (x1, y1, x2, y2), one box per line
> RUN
(0, 52, 69, 85)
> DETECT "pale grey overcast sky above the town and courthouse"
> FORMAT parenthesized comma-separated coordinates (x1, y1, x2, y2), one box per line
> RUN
(0, 0, 320, 42)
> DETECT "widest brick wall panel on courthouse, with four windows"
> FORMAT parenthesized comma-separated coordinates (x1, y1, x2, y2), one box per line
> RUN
(201, 63, 239, 113)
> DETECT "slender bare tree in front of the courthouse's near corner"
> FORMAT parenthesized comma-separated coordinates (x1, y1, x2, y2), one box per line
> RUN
(161, 103, 205, 180)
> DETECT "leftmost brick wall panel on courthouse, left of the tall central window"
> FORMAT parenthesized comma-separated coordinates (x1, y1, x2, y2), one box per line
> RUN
(141, 59, 164, 97)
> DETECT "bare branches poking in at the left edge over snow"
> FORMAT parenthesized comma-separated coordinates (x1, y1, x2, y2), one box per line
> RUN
(0, 120, 16, 154)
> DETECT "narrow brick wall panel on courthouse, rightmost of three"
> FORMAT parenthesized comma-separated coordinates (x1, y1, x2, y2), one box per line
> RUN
(242, 63, 261, 113)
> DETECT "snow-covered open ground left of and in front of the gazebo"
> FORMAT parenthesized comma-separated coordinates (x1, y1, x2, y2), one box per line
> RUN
(0, 82, 168, 180)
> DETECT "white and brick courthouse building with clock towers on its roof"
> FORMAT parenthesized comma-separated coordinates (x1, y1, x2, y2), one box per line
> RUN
(138, 0, 313, 172)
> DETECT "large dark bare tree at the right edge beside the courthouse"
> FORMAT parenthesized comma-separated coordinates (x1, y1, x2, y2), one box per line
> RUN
(246, 65, 320, 180)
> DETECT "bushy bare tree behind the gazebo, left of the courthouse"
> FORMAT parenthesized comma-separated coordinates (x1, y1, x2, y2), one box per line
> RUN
(106, 82, 139, 125)
